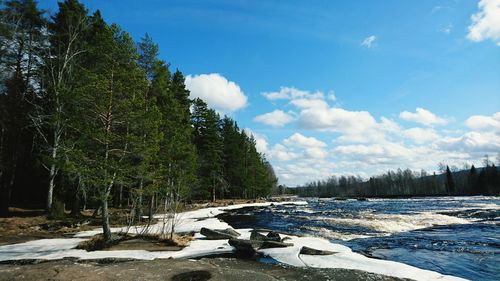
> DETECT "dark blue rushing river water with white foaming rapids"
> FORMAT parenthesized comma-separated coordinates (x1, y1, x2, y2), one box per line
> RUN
(220, 196, 500, 280)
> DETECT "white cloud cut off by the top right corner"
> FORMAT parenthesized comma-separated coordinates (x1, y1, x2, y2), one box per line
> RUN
(467, 0, 500, 45)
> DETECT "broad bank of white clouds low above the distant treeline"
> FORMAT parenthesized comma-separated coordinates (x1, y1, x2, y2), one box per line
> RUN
(261, 88, 500, 186)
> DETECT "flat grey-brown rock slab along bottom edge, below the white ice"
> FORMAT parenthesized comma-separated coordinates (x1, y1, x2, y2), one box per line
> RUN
(0, 258, 403, 281)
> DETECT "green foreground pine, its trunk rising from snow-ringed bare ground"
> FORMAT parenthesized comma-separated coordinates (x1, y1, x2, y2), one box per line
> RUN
(65, 11, 147, 241)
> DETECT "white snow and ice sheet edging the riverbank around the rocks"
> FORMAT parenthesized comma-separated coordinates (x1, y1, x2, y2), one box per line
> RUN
(0, 201, 464, 280)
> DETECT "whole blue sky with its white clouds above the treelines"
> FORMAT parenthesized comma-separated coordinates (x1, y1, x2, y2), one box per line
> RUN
(40, 0, 500, 186)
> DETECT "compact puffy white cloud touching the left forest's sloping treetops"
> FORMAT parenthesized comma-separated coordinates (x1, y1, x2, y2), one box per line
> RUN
(186, 73, 247, 112)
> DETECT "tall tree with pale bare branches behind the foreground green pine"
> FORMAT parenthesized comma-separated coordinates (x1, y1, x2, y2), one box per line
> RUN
(32, 0, 88, 210)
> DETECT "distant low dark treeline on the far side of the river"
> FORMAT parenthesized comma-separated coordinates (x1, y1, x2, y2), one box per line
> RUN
(292, 158, 500, 197)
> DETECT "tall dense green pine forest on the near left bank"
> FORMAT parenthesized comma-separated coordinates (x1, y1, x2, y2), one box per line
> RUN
(0, 0, 277, 241)
